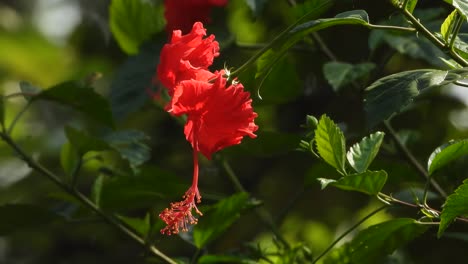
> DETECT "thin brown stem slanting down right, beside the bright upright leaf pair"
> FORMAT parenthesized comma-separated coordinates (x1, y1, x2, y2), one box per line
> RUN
(384, 121, 447, 198)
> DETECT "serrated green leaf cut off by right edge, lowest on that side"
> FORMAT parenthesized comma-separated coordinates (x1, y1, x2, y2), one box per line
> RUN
(437, 179, 468, 238)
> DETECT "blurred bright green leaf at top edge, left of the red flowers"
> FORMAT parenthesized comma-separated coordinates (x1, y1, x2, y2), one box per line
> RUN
(109, 0, 164, 54)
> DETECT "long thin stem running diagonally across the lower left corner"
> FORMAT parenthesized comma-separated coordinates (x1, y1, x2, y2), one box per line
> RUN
(0, 133, 176, 264)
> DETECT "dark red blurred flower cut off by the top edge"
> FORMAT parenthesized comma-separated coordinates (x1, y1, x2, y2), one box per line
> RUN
(164, 0, 227, 33)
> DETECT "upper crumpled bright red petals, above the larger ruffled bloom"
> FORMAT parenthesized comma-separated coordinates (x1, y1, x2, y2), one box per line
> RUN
(153, 22, 219, 96)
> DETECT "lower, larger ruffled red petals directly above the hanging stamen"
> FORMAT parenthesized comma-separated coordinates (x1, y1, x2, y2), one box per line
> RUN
(168, 72, 258, 159)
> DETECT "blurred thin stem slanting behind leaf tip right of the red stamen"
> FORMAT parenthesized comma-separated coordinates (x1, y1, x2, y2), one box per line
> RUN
(221, 158, 290, 249)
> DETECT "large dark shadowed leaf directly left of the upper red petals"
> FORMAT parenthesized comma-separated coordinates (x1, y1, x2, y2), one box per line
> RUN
(109, 42, 162, 120)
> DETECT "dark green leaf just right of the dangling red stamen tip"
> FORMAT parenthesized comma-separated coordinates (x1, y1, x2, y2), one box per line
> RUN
(193, 192, 249, 248)
